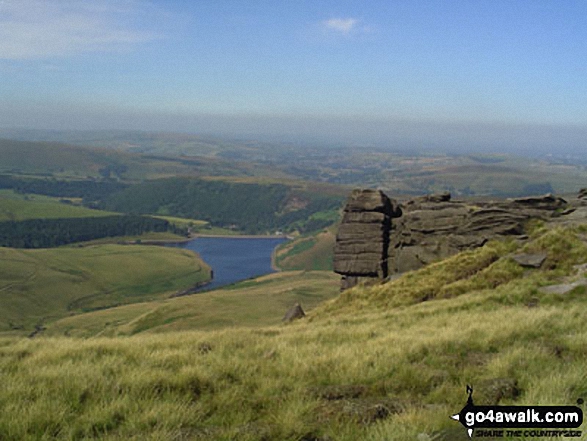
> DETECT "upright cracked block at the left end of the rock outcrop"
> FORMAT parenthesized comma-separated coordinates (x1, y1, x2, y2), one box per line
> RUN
(334, 190, 401, 289)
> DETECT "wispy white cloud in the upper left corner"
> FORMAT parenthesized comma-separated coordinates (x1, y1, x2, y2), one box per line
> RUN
(0, 0, 160, 60)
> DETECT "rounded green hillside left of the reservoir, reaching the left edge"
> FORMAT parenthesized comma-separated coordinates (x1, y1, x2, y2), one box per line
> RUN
(0, 245, 209, 334)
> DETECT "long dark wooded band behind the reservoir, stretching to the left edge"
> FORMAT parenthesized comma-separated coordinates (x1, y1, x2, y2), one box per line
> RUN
(0, 175, 344, 235)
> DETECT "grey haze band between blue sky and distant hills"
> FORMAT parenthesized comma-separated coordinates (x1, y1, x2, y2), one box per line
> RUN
(0, 110, 587, 156)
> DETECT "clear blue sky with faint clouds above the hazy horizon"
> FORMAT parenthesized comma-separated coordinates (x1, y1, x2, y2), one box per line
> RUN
(0, 0, 587, 150)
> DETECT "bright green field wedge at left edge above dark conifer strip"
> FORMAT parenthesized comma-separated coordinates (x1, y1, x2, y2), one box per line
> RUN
(0, 190, 116, 222)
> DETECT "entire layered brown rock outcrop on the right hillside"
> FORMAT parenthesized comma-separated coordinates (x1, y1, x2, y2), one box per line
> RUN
(334, 190, 567, 289)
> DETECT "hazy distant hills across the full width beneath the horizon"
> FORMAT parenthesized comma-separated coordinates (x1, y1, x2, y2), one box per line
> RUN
(0, 130, 587, 196)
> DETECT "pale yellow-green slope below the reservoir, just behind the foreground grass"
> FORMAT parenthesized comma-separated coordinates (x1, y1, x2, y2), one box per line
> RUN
(44, 271, 340, 337)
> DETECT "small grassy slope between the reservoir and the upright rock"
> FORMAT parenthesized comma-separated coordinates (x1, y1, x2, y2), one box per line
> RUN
(275, 226, 336, 271)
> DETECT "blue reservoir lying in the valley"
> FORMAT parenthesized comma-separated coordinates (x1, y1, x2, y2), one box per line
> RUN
(173, 237, 287, 291)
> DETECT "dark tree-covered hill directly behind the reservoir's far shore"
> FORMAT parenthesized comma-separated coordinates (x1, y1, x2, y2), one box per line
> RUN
(98, 178, 344, 234)
